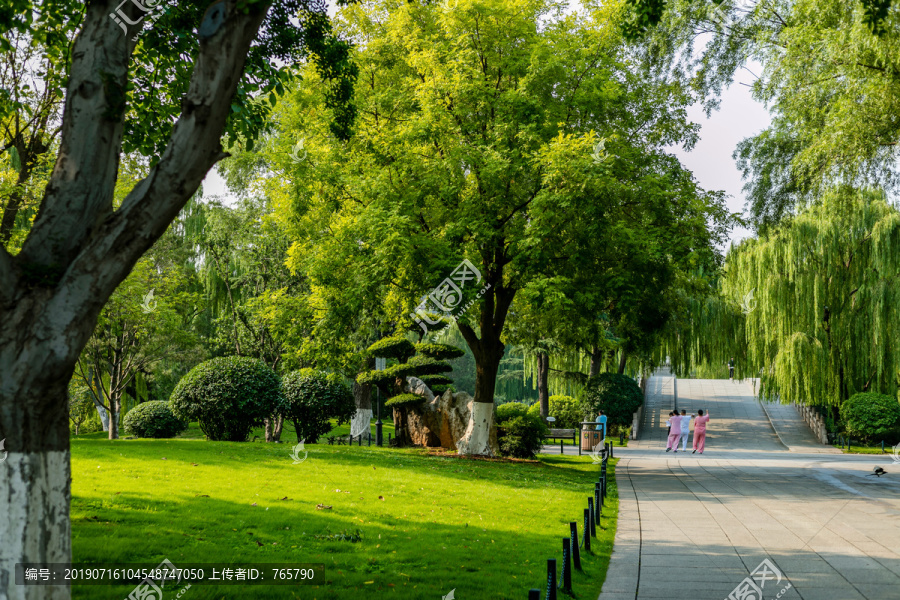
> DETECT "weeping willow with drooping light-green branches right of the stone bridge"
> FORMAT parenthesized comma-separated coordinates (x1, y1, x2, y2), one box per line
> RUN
(699, 189, 900, 409)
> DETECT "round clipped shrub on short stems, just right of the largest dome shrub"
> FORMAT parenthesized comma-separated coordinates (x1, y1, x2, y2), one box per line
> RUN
(281, 369, 356, 444)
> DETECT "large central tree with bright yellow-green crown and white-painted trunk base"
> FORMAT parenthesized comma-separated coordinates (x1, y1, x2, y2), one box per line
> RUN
(272, 0, 715, 454)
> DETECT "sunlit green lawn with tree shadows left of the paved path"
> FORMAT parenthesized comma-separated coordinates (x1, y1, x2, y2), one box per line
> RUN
(72, 429, 617, 600)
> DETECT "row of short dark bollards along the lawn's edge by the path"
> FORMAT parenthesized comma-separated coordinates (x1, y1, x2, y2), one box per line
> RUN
(528, 442, 613, 600)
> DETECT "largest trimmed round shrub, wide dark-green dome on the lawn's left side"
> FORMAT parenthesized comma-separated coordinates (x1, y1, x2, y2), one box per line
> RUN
(169, 356, 281, 442)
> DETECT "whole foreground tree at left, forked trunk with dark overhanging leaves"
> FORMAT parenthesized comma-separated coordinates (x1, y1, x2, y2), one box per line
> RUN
(0, 0, 354, 584)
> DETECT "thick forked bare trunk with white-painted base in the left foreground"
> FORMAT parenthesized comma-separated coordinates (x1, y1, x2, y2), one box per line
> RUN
(0, 0, 269, 600)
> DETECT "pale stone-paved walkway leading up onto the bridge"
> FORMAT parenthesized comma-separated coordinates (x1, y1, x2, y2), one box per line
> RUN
(600, 376, 900, 600)
